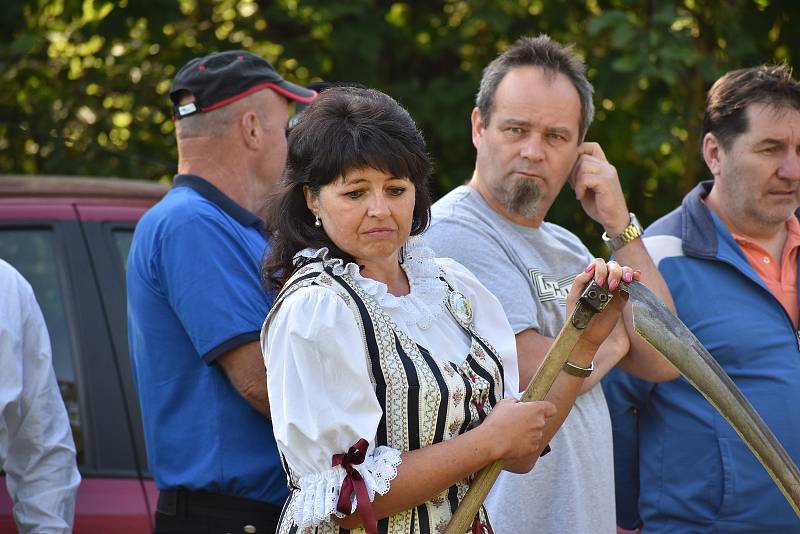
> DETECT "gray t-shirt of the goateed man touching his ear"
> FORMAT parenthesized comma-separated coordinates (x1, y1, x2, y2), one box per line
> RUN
(425, 186, 616, 534)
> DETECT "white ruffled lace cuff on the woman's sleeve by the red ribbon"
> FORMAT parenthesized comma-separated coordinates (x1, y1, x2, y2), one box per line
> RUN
(294, 446, 402, 529)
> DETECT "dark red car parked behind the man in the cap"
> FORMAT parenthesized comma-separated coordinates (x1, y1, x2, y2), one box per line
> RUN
(0, 175, 168, 534)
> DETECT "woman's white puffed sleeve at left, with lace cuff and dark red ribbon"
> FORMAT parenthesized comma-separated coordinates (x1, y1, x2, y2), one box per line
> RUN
(262, 286, 401, 528)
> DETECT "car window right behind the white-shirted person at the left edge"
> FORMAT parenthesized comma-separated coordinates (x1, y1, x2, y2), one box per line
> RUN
(0, 228, 83, 464)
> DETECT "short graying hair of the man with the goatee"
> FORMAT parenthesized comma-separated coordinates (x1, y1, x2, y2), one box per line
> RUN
(475, 34, 594, 142)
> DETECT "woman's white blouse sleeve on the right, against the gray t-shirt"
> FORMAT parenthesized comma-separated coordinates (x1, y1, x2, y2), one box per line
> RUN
(436, 258, 519, 397)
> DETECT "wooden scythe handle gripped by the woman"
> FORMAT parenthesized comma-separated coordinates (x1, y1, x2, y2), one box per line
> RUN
(445, 281, 627, 534)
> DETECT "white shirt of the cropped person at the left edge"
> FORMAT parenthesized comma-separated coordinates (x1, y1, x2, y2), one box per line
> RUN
(0, 261, 80, 533)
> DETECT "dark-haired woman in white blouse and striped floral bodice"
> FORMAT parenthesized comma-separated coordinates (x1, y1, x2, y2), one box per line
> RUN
(261, 88, 630, 534)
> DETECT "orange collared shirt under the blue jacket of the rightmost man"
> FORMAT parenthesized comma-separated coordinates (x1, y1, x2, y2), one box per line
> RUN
(733, 216, 800, 327)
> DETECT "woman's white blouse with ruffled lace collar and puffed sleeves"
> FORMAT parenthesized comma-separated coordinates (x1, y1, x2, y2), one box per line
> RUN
(262, 237, 519, 527)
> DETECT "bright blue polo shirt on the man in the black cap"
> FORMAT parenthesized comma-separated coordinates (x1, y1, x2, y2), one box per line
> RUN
(127, 175, 288, 506)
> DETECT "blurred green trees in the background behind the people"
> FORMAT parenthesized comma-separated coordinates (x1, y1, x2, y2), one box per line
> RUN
(0, 0, 800, 252)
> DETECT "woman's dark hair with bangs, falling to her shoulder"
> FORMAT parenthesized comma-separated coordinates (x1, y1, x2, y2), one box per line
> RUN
(261, 87, 432, 289)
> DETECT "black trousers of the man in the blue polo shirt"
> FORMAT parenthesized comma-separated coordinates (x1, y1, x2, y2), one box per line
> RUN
(155, 489, 281, 534)
